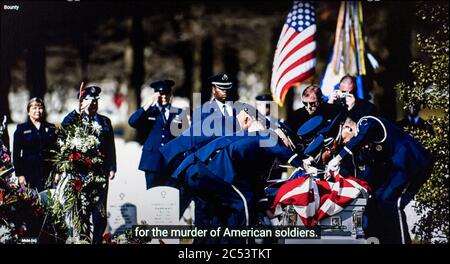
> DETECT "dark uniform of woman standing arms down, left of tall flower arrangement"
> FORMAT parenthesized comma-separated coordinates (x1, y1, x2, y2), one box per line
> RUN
(13, 119, 56, 191)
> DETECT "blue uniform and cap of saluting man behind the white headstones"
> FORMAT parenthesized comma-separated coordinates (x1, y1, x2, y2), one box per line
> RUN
(128, 80, 187, 189)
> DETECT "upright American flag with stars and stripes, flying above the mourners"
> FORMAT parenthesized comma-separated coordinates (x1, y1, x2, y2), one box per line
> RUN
(270, 1, 316, 106)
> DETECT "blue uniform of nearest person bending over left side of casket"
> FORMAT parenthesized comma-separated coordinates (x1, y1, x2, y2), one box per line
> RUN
(172, 130, 300, 243)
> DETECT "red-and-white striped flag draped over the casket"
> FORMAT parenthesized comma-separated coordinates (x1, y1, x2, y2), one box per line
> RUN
(272, 173, 369, 227)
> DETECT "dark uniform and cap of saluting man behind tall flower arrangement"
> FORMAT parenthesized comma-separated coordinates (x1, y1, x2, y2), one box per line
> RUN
(61, 86, 117, 244)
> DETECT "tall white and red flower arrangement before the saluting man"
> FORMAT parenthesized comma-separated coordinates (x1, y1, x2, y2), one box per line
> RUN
(50, 118, 107, 238)
